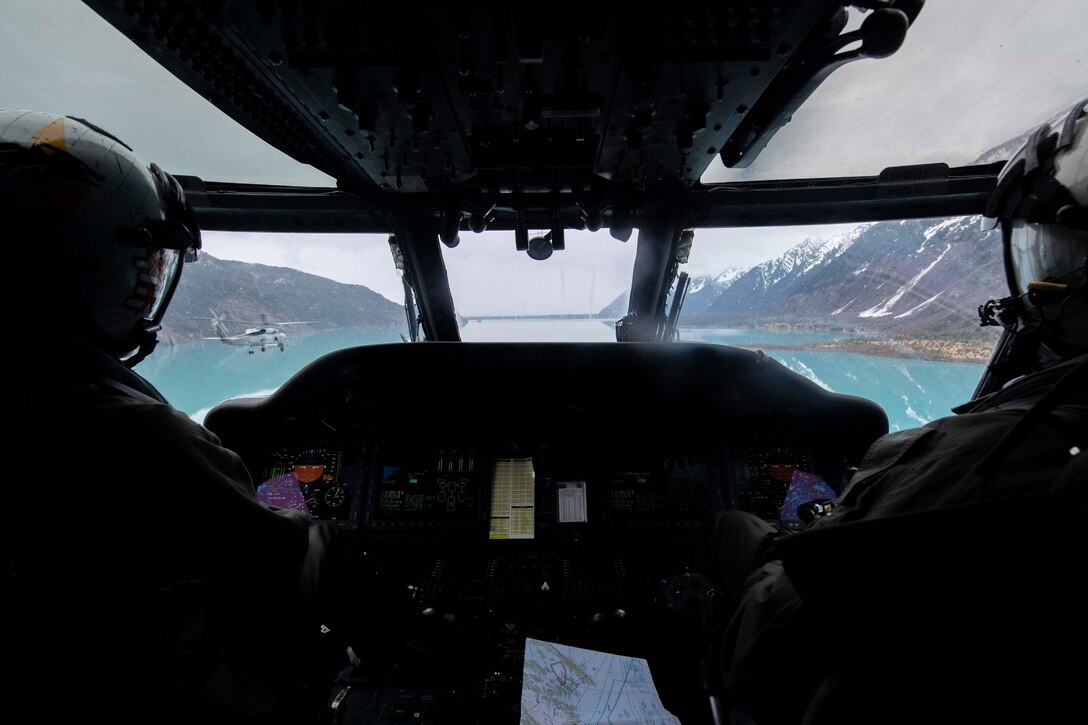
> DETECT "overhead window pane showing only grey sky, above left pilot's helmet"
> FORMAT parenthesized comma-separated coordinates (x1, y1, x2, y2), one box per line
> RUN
(0, 0, 335, 186)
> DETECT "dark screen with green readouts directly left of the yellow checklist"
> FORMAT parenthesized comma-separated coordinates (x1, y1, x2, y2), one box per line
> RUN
(369, 448, 484, 523)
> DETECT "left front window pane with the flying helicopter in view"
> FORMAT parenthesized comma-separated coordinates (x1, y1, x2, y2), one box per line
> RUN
(137, 232, 408, 421)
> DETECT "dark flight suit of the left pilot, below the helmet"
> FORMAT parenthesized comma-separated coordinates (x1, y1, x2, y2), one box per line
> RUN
(5, 330, 346, 723)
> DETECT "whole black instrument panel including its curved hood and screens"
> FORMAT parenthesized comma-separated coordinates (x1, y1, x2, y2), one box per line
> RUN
(218, 343, 888, 533)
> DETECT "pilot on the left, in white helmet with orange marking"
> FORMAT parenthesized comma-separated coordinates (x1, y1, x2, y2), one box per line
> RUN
(0, 109, 347, 723)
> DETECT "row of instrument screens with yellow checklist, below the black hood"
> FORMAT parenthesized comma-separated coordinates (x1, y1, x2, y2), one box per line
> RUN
(258, 435, 836, 531)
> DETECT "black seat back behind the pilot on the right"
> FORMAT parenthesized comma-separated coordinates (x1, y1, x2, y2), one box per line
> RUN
(781, 494, 1088, 725)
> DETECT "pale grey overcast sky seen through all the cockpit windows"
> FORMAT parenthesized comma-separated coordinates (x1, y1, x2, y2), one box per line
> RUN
(0, 0, 1088, 314)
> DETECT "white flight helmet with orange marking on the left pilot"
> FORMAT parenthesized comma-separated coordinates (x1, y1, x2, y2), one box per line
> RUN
(0, 109, 200, 366)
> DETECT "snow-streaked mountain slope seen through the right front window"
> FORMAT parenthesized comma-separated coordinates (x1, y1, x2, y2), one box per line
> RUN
(681, 217, 1006, 334)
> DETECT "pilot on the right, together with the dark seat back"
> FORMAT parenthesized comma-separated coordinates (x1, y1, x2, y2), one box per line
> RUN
(708, 100, 1088, 725)
